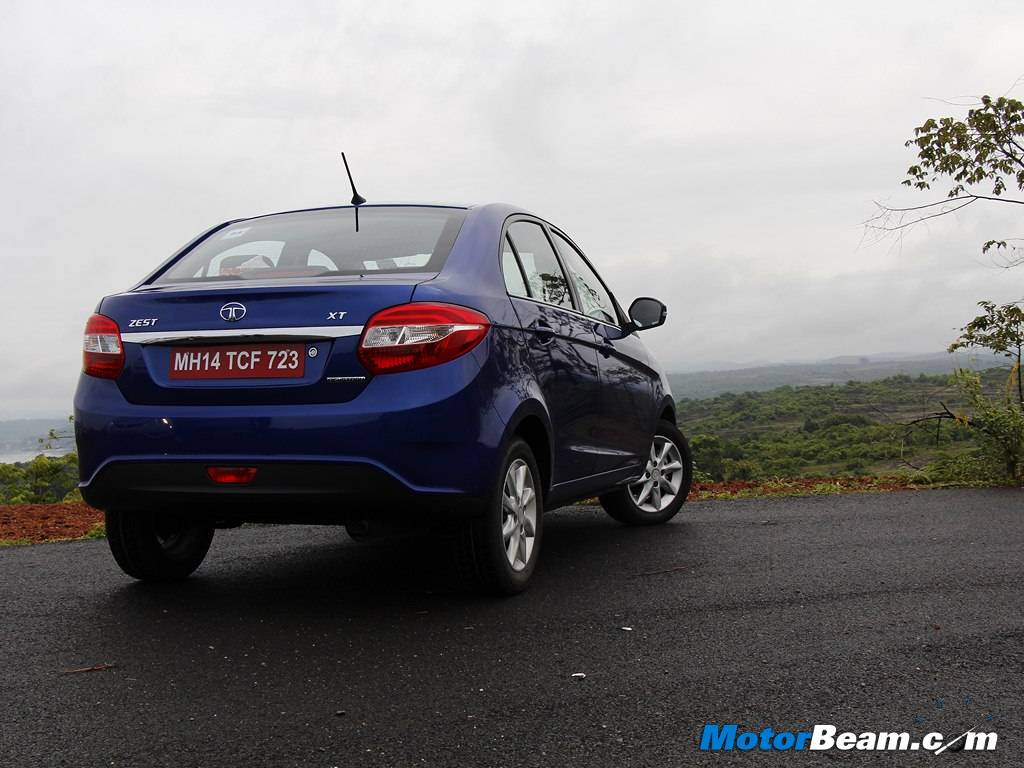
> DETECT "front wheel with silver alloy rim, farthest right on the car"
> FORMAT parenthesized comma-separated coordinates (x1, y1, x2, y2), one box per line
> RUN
(600, 420, 693, 525)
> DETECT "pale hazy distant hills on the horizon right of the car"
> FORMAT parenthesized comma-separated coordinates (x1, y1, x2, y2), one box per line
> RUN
(669, 352, 1009, 400)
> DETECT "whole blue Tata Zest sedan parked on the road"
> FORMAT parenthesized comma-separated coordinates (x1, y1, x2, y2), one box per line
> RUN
(75, 205, 692, 594)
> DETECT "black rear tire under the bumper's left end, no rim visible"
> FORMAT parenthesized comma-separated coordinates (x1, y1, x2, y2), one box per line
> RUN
(105, 510, 213, 582)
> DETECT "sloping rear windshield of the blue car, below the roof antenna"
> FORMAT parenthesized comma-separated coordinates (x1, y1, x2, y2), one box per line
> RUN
(153, 206, 466, 284)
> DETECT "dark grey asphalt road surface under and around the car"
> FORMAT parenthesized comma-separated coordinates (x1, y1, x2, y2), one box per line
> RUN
(0, 489, 1024, 768)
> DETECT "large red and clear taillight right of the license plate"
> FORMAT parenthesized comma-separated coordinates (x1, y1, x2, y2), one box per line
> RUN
(358, 302, 490, 374)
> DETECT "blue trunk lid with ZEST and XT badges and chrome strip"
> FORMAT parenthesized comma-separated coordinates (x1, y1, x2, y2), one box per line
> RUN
(99, 273, 423, 406)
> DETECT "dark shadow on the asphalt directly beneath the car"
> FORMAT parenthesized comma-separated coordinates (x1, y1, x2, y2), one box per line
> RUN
(96, 509, 692, 616)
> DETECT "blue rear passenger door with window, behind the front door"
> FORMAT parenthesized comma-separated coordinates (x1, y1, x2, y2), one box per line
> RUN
(502, 218, 604, 484)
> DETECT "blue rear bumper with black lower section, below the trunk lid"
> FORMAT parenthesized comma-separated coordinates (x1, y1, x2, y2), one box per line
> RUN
(75, 354, 505, 519)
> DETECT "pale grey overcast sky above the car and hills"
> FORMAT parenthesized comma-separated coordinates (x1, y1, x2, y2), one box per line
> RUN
(0, 0, 1024, 418)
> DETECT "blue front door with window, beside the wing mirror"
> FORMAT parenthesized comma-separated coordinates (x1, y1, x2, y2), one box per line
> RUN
(552, 229, 657, 470)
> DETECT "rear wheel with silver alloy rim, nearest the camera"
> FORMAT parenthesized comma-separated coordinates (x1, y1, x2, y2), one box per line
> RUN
(457, 438, 544, 595)
